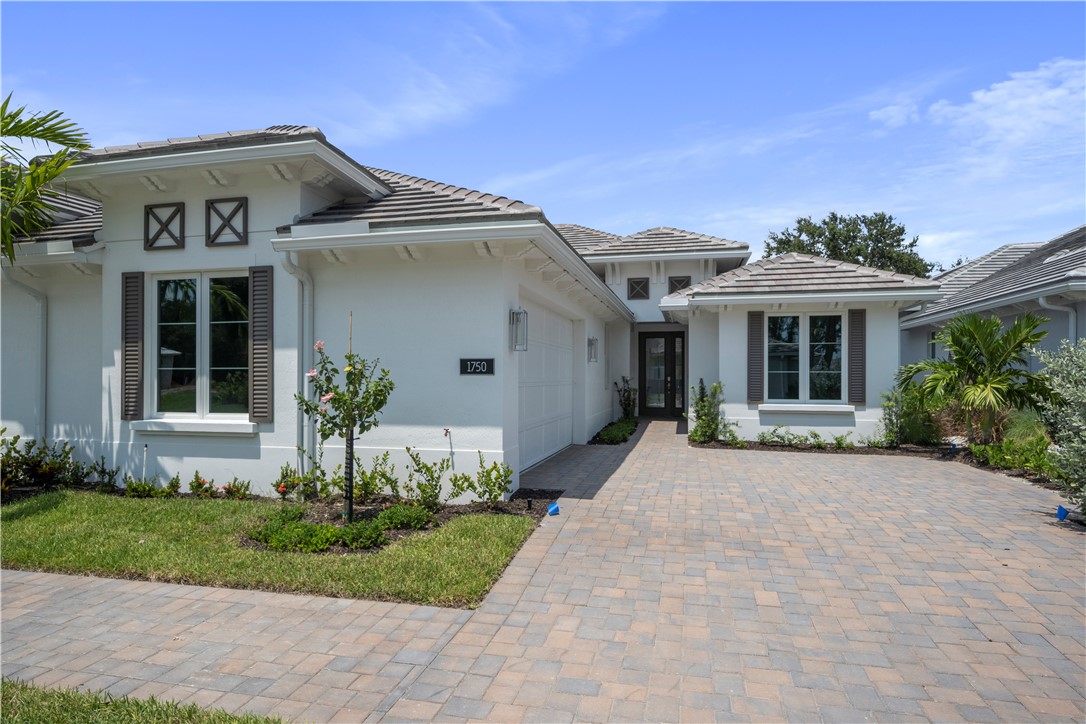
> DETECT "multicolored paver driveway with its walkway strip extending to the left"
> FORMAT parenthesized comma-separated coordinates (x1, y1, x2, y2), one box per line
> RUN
(2, 422, 1086, 722)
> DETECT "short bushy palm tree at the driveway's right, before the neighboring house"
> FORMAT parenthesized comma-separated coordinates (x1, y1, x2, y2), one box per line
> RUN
(897, 314, 1056, 443)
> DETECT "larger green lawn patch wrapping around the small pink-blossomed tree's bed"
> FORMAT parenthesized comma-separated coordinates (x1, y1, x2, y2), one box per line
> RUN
(0, 491, 535, 608)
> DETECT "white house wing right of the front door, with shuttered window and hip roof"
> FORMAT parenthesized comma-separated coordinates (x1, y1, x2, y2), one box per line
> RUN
(660, 253, 939, 442)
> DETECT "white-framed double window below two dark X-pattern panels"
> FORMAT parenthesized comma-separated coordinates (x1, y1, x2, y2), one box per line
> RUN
(151, 272, 250, 417)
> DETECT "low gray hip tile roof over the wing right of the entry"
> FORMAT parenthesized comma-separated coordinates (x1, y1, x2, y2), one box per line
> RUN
(668, 253, 938, 300)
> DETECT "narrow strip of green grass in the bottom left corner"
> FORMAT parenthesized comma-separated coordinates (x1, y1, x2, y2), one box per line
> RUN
(0, 679, 282, 724)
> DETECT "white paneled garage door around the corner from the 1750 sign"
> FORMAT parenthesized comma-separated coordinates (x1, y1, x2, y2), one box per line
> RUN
(517, 302, 573, 470)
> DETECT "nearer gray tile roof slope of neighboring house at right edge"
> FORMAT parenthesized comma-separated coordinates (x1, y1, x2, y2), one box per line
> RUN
(902, 226, 1086, 322)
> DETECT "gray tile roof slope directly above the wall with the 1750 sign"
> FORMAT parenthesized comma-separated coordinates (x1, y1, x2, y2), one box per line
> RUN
(286, 167, 543, 226)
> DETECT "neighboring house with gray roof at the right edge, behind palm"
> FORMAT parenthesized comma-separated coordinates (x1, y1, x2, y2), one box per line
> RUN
(900, 226, 1086, 369)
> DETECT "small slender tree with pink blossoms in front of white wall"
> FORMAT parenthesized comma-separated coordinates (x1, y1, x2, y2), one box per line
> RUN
(294, 323, 395, 522)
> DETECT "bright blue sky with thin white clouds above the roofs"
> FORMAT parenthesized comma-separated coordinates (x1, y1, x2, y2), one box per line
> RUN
(0, 2, 1086, 268)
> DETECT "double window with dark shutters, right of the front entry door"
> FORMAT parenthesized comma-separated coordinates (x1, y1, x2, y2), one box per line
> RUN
(766, 314, 844, 401)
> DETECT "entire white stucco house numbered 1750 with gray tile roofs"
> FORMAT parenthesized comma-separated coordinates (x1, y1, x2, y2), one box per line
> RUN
(0, 126, 938, 492)
